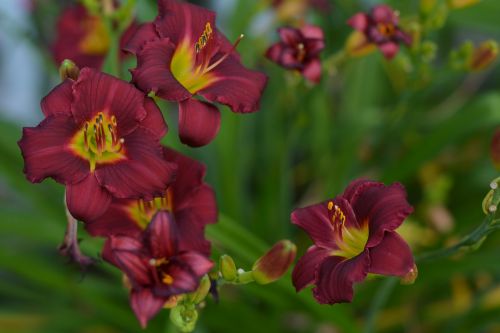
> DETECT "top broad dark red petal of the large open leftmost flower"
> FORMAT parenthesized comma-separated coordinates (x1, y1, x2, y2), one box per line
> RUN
(71, 68, 146, 137)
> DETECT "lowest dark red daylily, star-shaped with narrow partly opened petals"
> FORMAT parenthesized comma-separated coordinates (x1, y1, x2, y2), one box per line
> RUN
(103, 211, 213, 327)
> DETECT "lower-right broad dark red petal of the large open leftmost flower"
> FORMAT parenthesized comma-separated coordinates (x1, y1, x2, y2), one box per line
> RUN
(95, 127, 176, 201)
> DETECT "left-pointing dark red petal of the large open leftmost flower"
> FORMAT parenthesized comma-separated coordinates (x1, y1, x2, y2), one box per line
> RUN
(18, 115, 90, 184)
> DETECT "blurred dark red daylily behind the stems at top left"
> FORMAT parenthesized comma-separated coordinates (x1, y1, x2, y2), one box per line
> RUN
(52, 5, 138, 69)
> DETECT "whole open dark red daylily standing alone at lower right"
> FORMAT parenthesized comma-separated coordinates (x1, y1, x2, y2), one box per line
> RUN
(292, 180, 415, 304)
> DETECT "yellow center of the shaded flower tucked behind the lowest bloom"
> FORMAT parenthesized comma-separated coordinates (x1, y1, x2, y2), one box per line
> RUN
(128, 188, 174, 230)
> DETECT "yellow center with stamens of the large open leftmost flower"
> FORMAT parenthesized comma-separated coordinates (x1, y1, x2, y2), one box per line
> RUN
(69, 112, 126, 171)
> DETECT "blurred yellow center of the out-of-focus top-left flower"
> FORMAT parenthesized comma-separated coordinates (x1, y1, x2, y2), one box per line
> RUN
(78, 17, 111, 56)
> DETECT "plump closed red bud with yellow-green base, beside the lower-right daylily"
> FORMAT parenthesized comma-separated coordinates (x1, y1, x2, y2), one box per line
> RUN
(252, 240, 297, 284)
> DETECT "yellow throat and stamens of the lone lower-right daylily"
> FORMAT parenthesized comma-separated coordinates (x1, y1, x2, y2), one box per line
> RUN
(328, 201, 369, 259)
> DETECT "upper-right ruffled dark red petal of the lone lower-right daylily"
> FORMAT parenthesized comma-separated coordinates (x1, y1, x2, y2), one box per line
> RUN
(351, 182, 413, 248)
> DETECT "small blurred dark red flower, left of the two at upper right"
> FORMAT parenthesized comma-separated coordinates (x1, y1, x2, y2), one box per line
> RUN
(266, 25, 325, 83)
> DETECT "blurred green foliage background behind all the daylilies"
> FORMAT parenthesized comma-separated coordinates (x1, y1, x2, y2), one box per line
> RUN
(0, 0, 500, 333)
